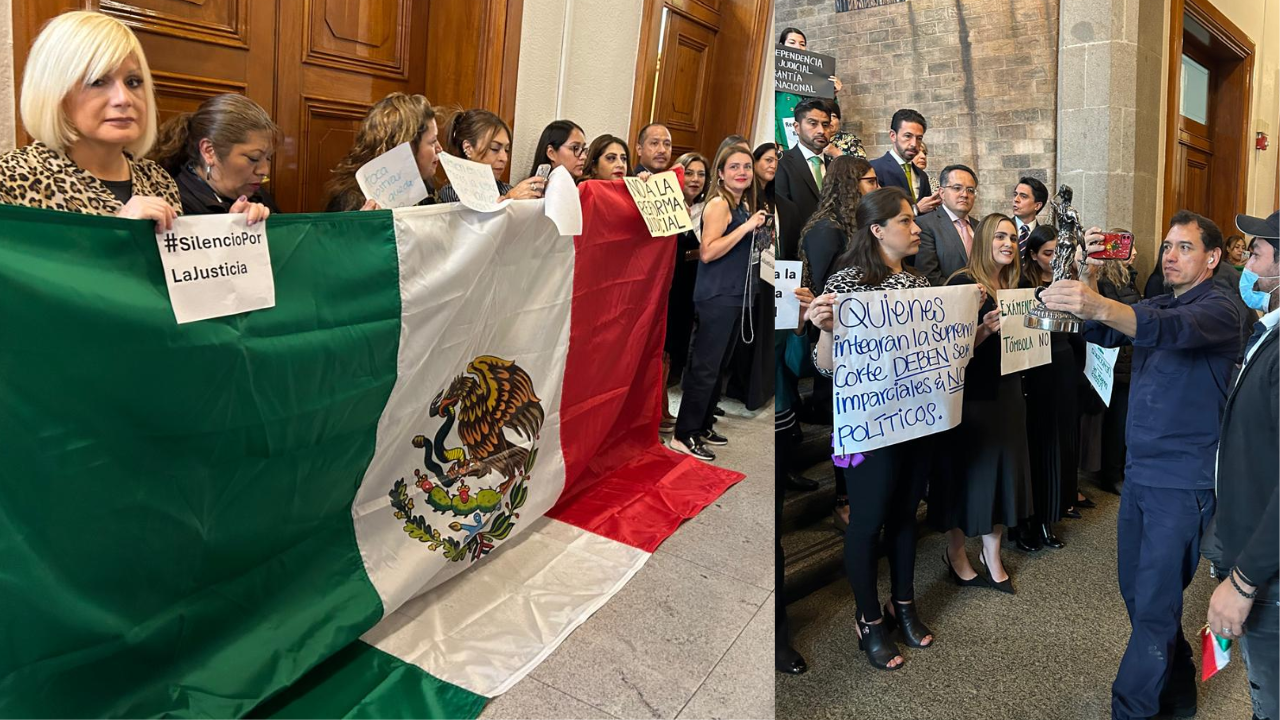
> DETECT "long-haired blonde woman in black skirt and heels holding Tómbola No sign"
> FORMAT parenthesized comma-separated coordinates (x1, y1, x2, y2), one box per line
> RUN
(929, 214, 1030, 594)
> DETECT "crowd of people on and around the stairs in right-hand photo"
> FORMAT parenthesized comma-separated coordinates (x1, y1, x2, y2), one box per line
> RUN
(776, 20, 1280, 719)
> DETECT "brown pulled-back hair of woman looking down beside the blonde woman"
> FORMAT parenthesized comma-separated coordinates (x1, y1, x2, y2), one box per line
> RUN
(150, 92, 280, 177)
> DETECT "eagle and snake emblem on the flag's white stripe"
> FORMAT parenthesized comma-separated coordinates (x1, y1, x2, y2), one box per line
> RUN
(388, 355, 545, 561)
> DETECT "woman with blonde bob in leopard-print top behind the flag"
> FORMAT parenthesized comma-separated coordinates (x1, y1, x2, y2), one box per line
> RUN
(0, 10, 182, 229)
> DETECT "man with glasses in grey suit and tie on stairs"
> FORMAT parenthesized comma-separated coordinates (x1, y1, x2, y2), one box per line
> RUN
(915, 165, 978, 286)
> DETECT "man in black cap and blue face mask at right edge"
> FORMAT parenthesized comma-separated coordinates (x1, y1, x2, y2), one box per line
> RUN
(1204, 213, 1280, 717)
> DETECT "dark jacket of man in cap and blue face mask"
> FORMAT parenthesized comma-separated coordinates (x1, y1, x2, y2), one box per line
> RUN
(1215, 323, 1280, 601)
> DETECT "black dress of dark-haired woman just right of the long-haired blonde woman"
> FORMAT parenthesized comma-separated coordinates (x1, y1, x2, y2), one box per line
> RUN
(1018, 274, 1084, 523)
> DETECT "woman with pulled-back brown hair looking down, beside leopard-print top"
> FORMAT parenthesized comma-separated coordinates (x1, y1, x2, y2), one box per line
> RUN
(151, 94, 280, 225)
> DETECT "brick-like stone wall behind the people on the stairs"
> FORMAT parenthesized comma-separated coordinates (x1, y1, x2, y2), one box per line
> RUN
(774, 0, 1059, 214)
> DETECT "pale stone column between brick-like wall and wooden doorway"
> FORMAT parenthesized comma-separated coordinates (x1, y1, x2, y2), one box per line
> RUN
(1050, 0, 1167, 266)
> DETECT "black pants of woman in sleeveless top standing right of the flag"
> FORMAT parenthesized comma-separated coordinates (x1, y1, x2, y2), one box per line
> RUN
(676, 302, 742, 442)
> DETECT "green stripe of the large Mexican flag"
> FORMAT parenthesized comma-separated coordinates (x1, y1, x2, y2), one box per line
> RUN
(0, 208, 401, 717)
